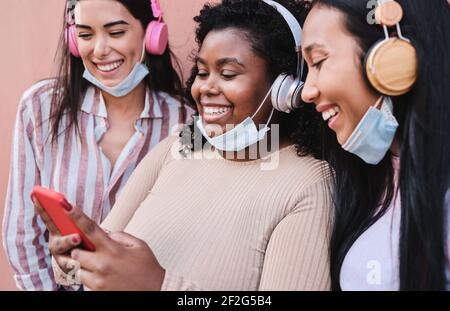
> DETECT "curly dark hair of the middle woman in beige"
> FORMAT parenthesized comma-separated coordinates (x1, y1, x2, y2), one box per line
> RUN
(180, 0, 323, 158)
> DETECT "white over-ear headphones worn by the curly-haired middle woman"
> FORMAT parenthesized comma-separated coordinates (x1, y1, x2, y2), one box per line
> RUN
(262, 0, 304, 113)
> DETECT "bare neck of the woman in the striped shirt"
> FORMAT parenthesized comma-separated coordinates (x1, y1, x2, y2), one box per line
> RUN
(101, 81, 146, 115)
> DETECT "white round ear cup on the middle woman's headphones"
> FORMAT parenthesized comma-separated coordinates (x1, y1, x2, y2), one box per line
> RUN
(271, 74, 304, 113)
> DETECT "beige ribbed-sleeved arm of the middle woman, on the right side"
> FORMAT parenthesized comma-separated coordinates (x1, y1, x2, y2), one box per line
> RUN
(259, 180, 331, 290)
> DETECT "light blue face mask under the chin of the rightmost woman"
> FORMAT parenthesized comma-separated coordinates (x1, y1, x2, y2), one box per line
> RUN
(342, 97, 398, 165)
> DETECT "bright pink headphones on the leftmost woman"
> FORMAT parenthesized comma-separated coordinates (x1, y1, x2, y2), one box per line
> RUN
(65, 0, 169, 57)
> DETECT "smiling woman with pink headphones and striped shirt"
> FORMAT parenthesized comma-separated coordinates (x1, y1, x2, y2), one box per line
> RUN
(3, 0, 191, 290)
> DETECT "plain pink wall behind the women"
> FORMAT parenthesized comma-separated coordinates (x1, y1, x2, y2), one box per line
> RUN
(0, 0, 206, 290)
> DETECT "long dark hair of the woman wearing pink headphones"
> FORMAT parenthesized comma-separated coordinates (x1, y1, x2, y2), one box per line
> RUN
(50, 0, 183, 141)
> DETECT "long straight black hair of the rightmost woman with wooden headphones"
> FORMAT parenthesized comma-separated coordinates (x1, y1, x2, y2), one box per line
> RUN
(306, 0, 450, 290)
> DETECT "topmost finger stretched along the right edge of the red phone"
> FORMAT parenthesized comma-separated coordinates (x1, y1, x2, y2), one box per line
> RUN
(67, 207, 112, 248)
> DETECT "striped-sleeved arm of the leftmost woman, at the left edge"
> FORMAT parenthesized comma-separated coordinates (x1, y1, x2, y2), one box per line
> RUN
(3, 97, 56, 290)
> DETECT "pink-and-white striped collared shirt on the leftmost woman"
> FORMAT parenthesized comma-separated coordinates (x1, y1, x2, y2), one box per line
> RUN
(3, 80, 192, 290)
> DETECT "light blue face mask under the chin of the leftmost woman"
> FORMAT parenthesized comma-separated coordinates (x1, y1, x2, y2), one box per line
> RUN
(83, 45, 149, 97)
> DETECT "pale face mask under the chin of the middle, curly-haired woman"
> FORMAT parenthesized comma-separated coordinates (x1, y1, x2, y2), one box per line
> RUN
(196, 88, 274, 151)
